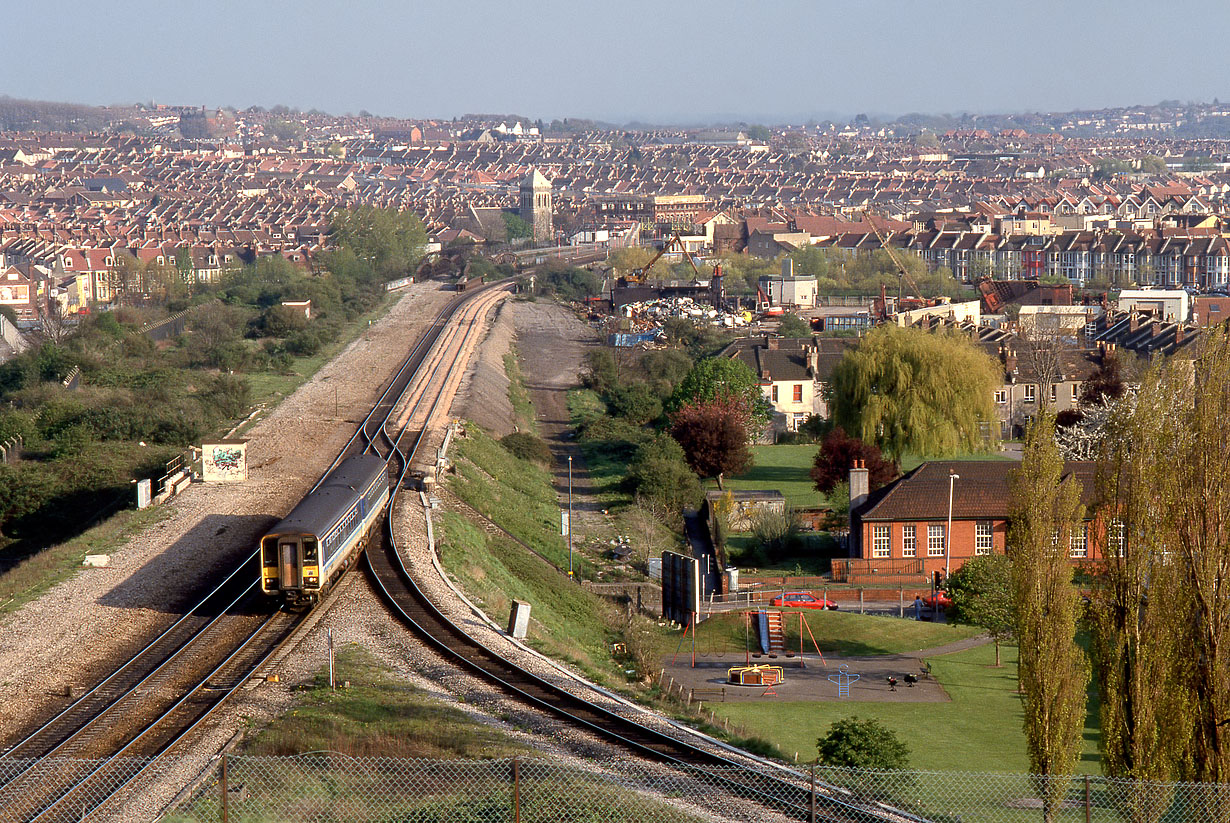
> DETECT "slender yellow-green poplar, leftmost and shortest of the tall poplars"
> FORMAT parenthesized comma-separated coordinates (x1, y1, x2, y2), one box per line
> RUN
(1007, 411, 1089, 823)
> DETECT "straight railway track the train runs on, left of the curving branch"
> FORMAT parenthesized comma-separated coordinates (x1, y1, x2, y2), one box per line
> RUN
(0, 279, 514, 823)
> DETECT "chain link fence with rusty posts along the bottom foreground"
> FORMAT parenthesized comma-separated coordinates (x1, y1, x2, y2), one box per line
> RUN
(0, 752, 1230, 823)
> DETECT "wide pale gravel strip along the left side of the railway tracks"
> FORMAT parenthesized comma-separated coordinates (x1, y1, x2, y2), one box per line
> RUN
(0, 283, 453, 741)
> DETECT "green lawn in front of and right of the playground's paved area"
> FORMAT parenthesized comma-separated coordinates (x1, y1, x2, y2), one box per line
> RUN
(708, 644, 1101, 774)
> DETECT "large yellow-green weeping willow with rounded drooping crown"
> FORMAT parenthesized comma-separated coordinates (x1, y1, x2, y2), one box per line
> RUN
(828, 326, 1000, 459)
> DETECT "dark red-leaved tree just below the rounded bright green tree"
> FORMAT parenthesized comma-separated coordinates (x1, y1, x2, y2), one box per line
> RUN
(670, 396, 752, 488)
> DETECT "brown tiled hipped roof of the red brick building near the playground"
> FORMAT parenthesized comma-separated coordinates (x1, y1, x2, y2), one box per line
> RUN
(857, 460, 1096, 522)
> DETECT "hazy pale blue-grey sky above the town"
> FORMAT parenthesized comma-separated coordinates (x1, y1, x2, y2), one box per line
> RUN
(9, 0, 1230, 124)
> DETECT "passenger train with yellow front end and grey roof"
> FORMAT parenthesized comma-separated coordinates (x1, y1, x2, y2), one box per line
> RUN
(261, 454, 389, 605)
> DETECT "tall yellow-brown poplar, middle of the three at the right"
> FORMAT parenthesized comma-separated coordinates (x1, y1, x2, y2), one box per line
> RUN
(1089, 368, 1192, 823)
